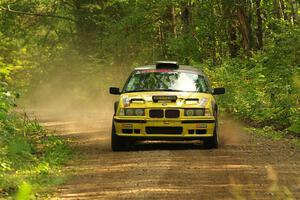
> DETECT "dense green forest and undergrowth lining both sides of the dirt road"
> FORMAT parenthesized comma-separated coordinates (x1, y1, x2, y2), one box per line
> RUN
(0, 0, 300, 199)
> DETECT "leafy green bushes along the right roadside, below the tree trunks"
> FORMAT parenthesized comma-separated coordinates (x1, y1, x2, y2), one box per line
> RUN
(207, 27, 300, 134)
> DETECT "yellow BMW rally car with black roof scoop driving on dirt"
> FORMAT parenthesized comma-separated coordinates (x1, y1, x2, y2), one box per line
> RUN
(110, 61, 225, 151)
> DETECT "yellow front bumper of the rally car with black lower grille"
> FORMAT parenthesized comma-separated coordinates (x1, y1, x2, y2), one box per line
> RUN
(113, 116, 215, 140)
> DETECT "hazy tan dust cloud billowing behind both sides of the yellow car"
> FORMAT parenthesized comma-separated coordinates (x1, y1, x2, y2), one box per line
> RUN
(21, 56, 247, 145)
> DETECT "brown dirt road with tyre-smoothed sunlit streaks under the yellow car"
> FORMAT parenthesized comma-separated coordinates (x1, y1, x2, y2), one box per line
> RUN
(33, 111, 300, 199)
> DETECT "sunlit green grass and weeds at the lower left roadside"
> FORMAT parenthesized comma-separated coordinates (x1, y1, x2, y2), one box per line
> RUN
(0, 114, 72, 199)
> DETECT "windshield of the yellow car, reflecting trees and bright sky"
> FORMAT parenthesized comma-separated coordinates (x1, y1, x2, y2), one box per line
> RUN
(123, 70, 208, 93)
